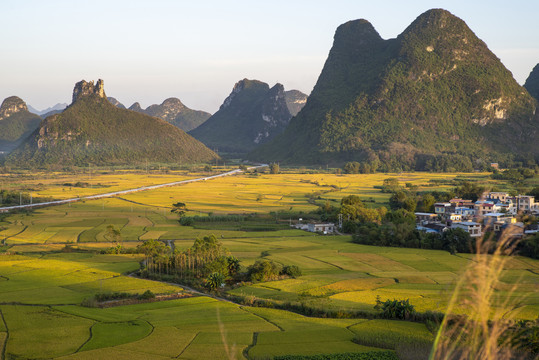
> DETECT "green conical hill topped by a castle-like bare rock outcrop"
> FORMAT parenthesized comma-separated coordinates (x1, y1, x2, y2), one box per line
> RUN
(7, 80, 217, 165)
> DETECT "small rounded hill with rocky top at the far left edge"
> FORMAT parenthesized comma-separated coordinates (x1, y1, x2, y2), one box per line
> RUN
(0, 96, 41, 152)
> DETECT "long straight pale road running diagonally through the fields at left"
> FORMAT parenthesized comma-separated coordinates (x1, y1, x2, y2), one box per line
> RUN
(0, 164, 268, 212)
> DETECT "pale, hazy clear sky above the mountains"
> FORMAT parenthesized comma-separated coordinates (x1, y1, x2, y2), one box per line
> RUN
(0, 0, 539, 113)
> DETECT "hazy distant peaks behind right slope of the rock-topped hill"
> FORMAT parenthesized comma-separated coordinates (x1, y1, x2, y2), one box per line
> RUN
(107, 97, 211, 131)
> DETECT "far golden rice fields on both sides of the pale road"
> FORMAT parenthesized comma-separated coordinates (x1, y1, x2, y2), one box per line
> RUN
(0, 167, 487, 213)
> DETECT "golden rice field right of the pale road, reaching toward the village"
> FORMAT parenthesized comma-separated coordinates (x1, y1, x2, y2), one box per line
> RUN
(123, 173, 485, 214)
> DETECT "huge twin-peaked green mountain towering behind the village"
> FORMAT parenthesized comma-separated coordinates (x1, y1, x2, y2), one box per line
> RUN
(250, 9, 539, 170)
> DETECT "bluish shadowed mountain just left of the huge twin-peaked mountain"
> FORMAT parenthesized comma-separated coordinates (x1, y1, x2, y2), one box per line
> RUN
(189, 79, 307, 153)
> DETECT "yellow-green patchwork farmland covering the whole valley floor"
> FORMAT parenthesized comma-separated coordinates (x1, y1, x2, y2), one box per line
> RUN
(0, 173, 539, 359)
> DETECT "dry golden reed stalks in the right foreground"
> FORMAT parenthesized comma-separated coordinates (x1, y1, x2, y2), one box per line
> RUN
(429, 228, 519, 360)
